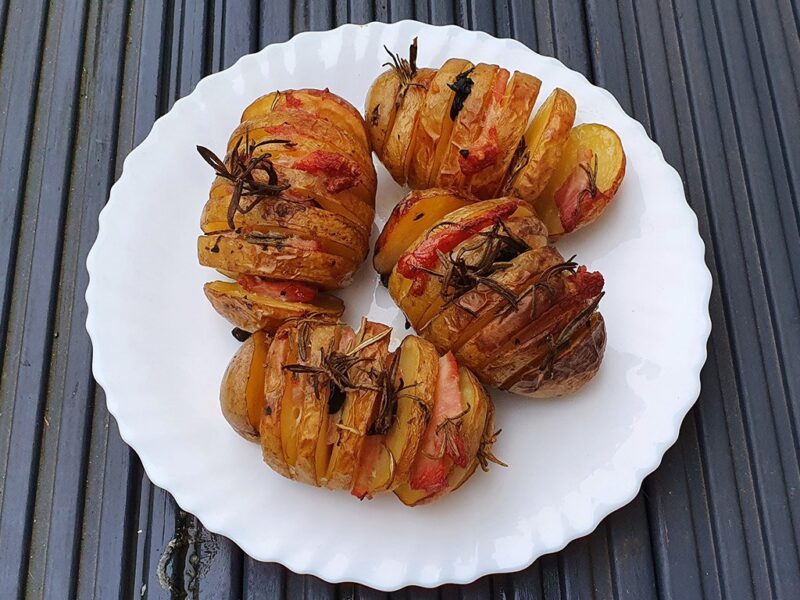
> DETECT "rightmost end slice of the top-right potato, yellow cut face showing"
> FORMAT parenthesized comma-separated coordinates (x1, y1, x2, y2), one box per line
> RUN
(534, 123, 625, 237)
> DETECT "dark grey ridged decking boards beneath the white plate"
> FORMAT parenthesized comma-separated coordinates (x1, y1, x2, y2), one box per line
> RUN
(0, 0, 800, 600)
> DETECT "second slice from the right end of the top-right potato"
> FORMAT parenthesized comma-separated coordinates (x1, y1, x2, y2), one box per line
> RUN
(506, 88, 575, 202)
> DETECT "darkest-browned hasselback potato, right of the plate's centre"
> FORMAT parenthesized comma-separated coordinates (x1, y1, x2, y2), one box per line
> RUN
(373, 190, 606, 397)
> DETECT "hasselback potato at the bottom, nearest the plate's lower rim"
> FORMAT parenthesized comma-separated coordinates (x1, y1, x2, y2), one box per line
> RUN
(220, 316, 502, 506)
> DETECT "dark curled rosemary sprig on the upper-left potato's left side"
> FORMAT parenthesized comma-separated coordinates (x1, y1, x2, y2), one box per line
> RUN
(197, 133, 292, 229)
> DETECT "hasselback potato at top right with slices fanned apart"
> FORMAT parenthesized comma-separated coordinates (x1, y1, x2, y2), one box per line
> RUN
(365, 39, 625, 238)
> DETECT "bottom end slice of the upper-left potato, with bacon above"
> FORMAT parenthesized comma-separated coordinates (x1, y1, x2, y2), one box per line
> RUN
(203, 281, 344, 332)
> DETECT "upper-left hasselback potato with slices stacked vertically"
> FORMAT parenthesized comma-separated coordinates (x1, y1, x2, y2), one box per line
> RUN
(197, 89, 376, 331)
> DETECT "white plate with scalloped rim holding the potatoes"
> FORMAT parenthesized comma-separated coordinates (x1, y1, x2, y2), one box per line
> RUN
(86, 21, 711, 590)
